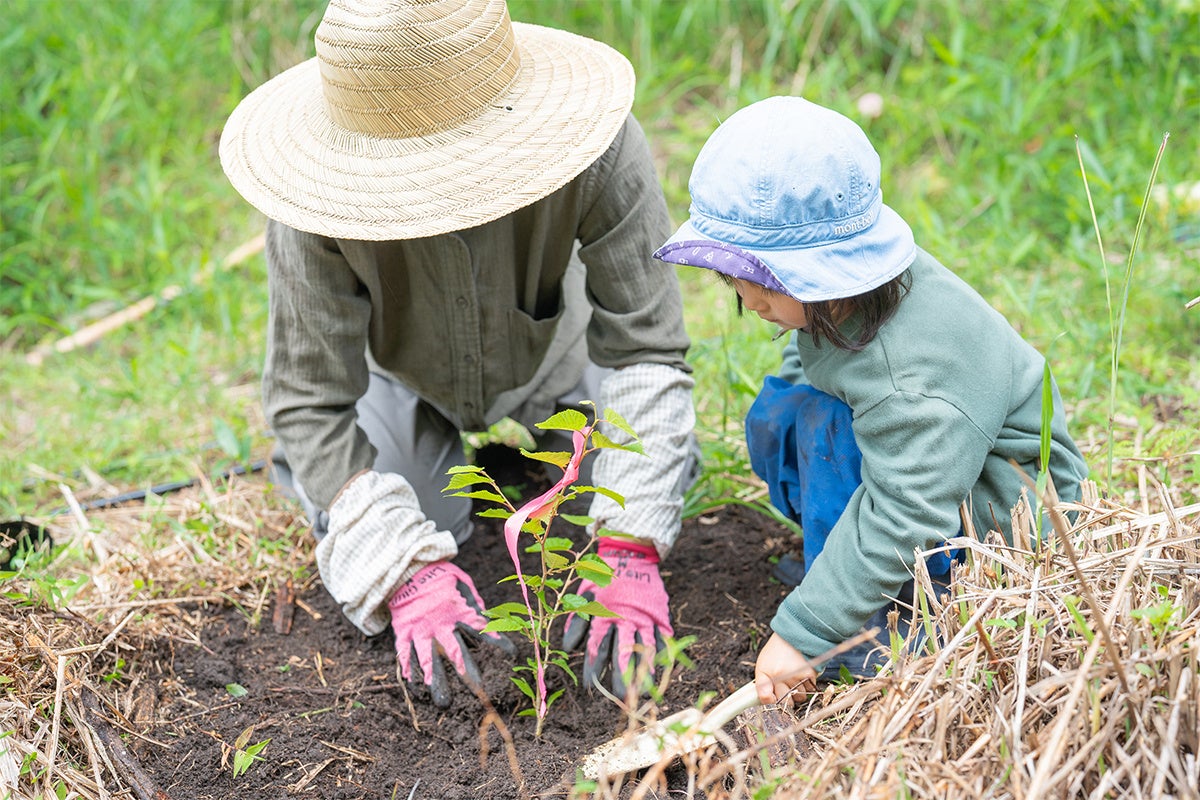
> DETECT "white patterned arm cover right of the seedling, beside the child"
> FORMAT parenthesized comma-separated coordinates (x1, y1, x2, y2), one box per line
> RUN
(589, 363, 697, 555)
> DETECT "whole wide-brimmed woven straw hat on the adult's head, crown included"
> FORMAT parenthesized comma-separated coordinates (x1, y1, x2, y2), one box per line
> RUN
(221, 0, 634, 241)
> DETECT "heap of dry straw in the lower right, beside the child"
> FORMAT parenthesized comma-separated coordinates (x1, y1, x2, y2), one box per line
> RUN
(593, 485, 1200, 800)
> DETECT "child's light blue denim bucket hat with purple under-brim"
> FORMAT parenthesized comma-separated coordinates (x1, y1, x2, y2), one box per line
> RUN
(654, 97, 917, 302)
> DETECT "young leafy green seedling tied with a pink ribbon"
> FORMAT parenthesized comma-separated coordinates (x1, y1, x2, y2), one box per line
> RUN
(444, 403, 643, 736)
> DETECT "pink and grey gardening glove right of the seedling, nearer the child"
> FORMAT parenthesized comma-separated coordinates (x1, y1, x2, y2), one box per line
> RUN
(563, 537, 674, 697)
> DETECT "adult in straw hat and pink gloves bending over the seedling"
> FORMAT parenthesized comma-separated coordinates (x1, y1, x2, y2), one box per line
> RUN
(221, 0, 695, 705)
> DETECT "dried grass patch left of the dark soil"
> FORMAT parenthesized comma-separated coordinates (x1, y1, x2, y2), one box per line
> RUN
(0, 481, 311, 800)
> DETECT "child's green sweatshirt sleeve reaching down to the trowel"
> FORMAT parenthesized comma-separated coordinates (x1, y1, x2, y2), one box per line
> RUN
(772, 392, 991, 658)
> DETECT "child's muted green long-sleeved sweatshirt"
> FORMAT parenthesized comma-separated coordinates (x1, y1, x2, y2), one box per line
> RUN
(772, 249, 1087, 658)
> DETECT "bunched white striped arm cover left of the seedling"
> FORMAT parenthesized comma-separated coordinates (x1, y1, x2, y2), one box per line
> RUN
(317, 471, 458, 636)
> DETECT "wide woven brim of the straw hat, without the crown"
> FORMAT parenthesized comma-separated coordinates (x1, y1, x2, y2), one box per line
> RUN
(221, 23, 634, 241)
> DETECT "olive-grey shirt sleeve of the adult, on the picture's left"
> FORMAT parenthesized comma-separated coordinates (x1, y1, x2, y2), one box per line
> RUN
(263, 221, 376, 509)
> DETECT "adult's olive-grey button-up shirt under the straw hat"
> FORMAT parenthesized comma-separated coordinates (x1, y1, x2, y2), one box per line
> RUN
(264, 116, 690, 507)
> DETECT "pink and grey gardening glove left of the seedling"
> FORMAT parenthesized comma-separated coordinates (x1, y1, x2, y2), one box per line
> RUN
(388, 561, 516, 708)
